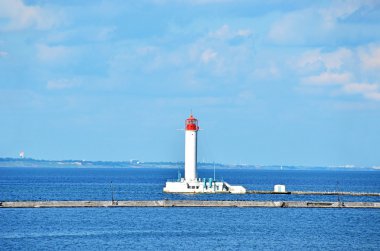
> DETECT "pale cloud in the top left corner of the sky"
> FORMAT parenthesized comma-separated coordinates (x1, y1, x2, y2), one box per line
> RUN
(0, 0, 57, 30)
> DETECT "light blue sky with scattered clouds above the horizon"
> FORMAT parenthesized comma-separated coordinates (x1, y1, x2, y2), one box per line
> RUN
(0, 0, 380, 166)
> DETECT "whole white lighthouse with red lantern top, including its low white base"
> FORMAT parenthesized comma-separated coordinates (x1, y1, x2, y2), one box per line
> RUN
(164, 114, 246, 193)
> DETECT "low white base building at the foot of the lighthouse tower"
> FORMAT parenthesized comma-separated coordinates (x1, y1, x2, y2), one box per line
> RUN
(164, 178, 246, 194)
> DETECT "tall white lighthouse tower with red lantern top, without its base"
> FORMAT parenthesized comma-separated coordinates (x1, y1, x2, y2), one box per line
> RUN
(185, 114, 199, 181)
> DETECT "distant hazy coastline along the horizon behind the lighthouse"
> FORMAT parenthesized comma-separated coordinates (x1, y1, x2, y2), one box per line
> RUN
(0, 158, 380, 171)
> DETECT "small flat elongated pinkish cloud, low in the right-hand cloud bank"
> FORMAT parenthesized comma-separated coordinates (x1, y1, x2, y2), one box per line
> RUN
(302, 72, 351, 85)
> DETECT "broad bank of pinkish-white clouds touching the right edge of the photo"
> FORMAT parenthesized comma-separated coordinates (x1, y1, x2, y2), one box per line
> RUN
(295, 45, 380, 101)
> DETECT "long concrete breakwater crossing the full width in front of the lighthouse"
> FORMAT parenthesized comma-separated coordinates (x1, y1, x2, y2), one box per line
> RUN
(0, 200, 380, 209)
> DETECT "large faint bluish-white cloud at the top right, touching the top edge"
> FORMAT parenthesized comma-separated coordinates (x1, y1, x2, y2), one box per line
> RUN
(268, 0, 378, 45)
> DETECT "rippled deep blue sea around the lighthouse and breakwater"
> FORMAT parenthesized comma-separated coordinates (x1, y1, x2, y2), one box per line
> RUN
(0, 168, 380, 250)
